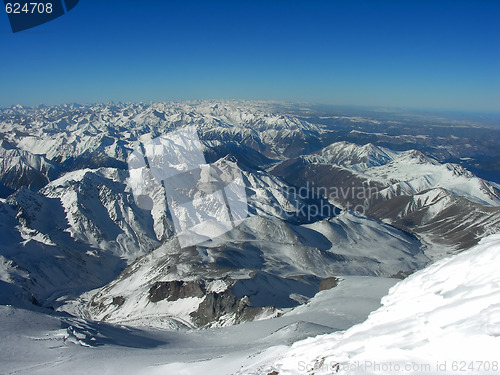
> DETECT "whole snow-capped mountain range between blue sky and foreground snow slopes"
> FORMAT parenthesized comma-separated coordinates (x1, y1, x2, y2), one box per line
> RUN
(0, 101, 500, 374)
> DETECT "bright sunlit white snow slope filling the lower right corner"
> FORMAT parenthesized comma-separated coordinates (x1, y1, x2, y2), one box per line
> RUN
(249, 234, 500, 374)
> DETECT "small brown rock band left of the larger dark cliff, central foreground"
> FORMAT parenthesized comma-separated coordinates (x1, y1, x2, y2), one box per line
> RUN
(149, 280, 205, 302)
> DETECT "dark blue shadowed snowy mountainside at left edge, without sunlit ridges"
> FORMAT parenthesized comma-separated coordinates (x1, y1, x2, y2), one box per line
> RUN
(0, 189, 125, 307)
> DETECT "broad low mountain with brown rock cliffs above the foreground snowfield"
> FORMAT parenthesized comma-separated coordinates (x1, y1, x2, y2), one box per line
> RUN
(82, 214, 428, 327)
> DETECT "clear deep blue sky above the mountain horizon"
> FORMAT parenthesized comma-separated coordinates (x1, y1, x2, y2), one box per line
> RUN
(0, 0, 500, 111)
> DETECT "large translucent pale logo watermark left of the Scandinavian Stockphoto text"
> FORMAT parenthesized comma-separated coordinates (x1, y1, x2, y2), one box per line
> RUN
(128, 126, 248, 247)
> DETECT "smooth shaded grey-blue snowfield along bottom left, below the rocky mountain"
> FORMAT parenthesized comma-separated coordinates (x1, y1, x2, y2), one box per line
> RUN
(0, 277, 397, 375)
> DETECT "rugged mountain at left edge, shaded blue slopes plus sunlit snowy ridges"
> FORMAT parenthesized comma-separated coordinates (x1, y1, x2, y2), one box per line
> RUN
(0, 168, 162, 306)
